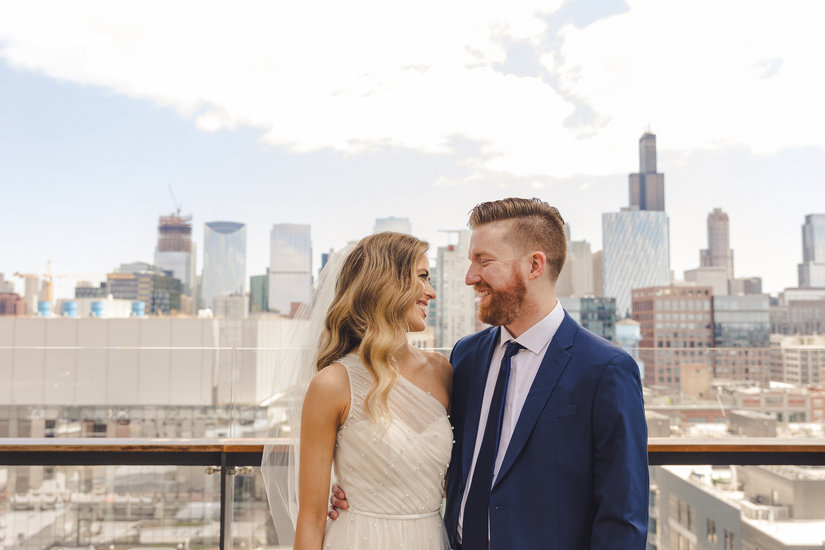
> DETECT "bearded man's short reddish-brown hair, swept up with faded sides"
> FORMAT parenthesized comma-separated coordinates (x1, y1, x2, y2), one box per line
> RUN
(467, 197, 567, 283)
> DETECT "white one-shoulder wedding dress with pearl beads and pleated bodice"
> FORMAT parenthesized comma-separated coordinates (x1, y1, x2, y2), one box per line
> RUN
(324, 353, 453, 550)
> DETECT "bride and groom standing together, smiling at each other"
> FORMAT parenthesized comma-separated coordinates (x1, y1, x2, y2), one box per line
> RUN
(268, 198, 648, 550)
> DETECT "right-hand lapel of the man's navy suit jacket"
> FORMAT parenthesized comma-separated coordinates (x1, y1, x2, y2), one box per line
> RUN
(493, 312, 578, 487)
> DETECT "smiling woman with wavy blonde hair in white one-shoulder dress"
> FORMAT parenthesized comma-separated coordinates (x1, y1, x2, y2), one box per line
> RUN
(272, 232, 453, 550)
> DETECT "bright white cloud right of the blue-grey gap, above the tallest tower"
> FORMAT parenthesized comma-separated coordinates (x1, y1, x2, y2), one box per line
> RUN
(542, 0, 825, 166)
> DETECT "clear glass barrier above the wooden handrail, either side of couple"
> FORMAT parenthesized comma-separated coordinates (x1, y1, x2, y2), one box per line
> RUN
(0, 344, 825, 439)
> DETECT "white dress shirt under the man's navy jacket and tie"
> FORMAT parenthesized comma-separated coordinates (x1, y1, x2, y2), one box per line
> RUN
(458, 301, 564, 537)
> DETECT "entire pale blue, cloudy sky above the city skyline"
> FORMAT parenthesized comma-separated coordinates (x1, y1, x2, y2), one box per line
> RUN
(0, 0, 825, 302)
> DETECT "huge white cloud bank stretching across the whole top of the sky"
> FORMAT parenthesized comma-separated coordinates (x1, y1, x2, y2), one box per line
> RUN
(0, 0, 825, 179)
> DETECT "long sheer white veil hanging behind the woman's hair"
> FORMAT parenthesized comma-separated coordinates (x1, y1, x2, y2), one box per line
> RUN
(261, 244, 355, 546)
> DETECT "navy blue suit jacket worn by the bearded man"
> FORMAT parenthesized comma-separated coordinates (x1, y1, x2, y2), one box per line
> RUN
(444, 312, 649, 550)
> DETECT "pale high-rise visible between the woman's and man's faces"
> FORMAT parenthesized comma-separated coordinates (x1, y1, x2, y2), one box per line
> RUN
(435, 230, 476, 348)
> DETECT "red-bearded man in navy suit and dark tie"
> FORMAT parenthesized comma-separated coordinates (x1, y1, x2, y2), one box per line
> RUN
(331, 198, 649, 550)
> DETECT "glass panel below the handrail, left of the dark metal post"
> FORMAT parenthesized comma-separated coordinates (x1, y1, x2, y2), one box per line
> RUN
(0, 465, 221, 550)
